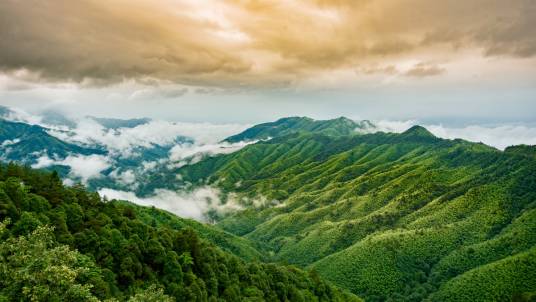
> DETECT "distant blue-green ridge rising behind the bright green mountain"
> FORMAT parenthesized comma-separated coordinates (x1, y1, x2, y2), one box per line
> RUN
(224, 117, 374, 143)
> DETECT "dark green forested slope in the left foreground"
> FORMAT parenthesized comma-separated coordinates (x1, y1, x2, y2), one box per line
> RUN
(0, 164, 360, 301)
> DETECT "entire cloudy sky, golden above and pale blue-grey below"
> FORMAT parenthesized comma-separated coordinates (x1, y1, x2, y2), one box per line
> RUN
(0, 0, 536, 127)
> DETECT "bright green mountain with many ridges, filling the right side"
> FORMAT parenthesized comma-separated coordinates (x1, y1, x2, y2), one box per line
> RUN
(177, 124, 536, 301)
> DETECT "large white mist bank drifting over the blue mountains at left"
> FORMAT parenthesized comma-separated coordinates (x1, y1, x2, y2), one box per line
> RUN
(0, 105, 253, 190)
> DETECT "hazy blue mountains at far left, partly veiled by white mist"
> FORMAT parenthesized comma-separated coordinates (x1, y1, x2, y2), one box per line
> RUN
(0, 112, 193, 194)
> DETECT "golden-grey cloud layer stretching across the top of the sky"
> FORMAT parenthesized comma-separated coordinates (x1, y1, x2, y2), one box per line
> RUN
(0, 0, 536, 87)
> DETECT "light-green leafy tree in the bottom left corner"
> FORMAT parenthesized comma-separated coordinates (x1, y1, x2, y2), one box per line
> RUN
(0, 221, 102, 301)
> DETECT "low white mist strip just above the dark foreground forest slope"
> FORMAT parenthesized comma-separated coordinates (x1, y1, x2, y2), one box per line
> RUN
(99, 186, 241, 221)
